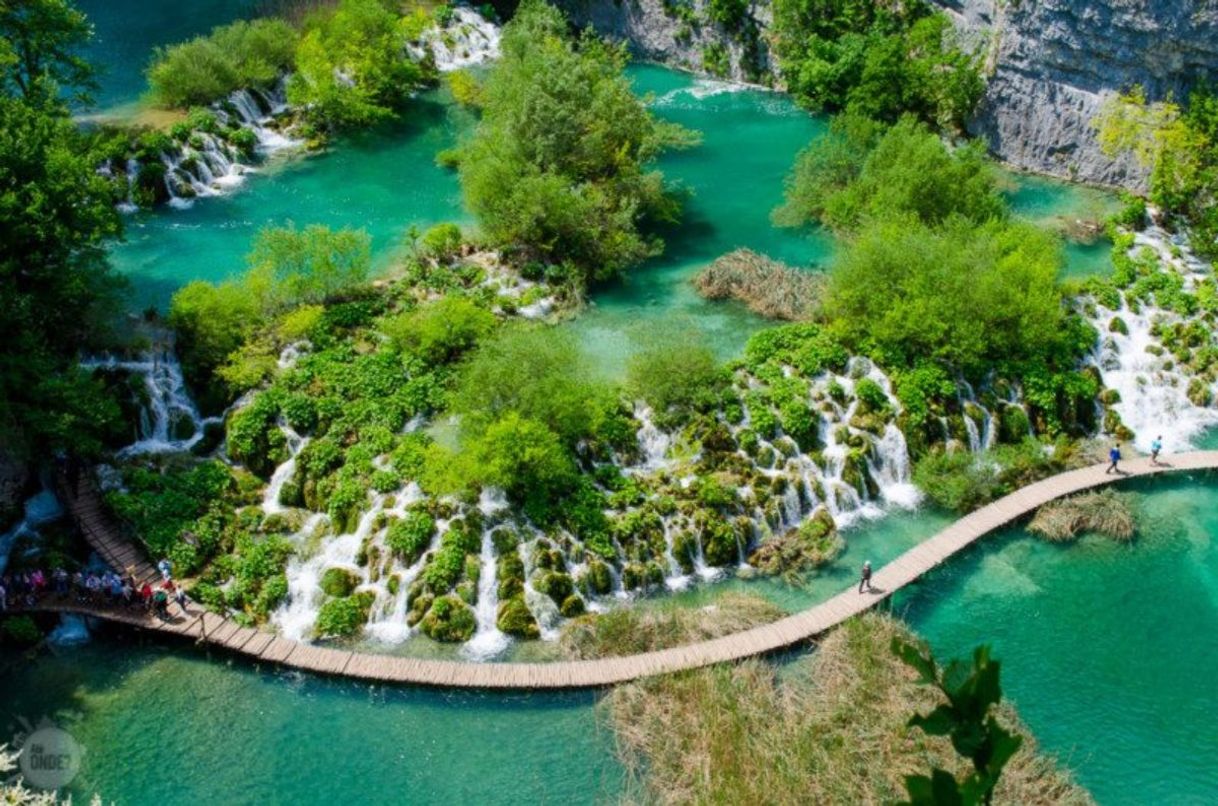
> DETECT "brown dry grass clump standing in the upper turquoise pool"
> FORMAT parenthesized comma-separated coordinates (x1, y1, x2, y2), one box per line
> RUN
(694, 250, 825, 321)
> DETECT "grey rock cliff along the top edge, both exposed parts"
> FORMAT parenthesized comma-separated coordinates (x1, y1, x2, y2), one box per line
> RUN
(560, 0, 1218, 189)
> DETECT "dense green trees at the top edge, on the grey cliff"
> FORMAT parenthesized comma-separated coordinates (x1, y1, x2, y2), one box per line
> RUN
(772, 0, 984, 129)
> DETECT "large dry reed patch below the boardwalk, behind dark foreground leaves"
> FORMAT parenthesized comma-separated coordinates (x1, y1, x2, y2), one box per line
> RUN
(603, 614, 1093, 805)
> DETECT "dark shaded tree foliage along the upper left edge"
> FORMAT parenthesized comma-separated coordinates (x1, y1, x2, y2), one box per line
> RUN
(0, 0, 129, 455)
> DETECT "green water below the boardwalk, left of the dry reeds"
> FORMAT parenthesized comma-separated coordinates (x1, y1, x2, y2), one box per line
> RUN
(0, 633, 622, 804)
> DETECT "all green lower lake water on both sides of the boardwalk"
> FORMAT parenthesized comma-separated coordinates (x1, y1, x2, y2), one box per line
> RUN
(7, 475, 1218, 805)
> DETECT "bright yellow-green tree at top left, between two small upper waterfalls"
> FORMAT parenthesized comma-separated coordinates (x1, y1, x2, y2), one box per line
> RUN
(287, 0, 425, 129)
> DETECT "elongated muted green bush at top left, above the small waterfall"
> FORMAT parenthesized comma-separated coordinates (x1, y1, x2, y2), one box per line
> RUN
(147, 18, 297, 108)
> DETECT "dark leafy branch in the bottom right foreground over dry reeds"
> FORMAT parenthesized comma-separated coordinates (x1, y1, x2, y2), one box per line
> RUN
(892, 637, 1023, 806)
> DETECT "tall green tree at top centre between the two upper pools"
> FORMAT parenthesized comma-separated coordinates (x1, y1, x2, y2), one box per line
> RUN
(458, 0, 692, 280)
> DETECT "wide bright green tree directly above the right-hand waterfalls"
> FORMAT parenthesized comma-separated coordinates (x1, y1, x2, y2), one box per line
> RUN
(826, 217, 1066, 373)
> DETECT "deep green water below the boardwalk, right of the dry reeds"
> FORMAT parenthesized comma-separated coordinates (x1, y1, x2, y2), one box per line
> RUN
(896, 476, 1218, 804)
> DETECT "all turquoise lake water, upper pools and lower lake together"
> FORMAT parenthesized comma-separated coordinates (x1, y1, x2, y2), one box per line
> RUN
(0, 6, 1198, 804)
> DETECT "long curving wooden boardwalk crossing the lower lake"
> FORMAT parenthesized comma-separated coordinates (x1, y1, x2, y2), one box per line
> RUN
(30, 450, 1218, 689)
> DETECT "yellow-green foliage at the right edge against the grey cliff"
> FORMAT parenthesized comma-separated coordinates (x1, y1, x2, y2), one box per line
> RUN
(1094, 85, 1218, 258)
